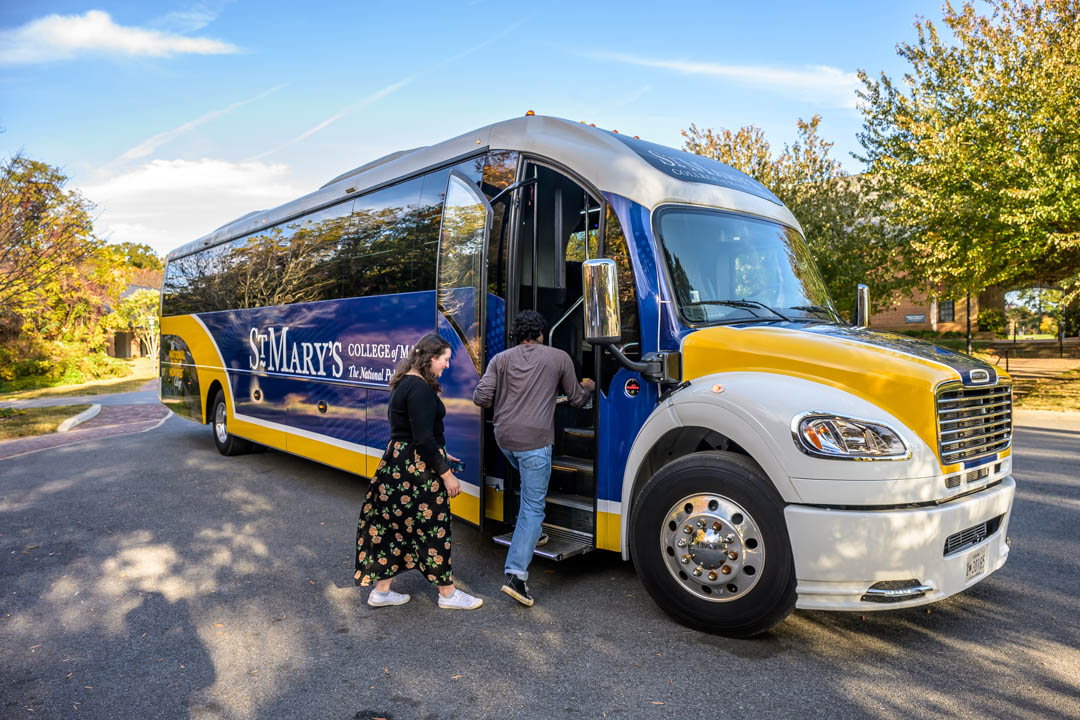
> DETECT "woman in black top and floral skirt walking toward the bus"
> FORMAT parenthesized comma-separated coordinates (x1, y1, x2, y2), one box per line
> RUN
(353, 332, 484, 610)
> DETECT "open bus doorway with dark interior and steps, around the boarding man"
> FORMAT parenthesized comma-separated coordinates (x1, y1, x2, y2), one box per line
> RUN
(496, 162, 602, 560)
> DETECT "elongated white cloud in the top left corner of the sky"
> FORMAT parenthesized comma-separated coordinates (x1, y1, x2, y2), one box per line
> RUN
(0, 10, 240, 65)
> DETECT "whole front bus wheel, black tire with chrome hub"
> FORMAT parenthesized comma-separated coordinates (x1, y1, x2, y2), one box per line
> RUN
(630, 451, 796, 637)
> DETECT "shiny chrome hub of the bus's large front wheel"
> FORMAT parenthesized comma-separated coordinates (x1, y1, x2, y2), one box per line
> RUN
(660, 493, 765, 602)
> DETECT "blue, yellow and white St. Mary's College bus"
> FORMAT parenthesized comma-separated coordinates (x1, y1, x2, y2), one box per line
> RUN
(161, 114, 1015, 636)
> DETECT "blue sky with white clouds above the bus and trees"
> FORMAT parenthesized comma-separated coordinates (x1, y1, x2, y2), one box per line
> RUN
(0, 0, 941, 254)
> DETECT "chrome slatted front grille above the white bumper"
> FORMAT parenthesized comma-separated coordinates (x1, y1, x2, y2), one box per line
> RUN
(937, 382, 1012, 465)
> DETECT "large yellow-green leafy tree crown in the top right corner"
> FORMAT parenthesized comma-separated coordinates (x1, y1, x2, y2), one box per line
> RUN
(859, 0, 1080, 301)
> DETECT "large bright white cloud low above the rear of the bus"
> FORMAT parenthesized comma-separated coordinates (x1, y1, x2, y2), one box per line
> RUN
(80, 158, 307, 253)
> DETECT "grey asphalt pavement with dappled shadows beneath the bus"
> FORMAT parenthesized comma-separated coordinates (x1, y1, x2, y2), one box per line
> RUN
(0, 417, 1080, 720)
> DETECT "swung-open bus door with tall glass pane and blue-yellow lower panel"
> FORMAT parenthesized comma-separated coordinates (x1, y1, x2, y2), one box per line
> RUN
(435, 171, 491, 527)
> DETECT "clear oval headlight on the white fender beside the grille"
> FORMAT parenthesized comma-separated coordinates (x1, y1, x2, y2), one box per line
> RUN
(792, 412, 912, 460)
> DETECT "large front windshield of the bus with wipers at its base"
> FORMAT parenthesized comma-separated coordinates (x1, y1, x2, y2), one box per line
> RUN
(658, 207, 840, 324)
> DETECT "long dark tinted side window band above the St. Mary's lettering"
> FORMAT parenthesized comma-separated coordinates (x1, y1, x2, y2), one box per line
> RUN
(162, 155, 484, 315)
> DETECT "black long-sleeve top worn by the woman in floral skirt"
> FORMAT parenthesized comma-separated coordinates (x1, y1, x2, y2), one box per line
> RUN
(387, 375, 450, 476)
